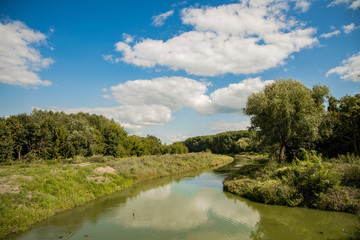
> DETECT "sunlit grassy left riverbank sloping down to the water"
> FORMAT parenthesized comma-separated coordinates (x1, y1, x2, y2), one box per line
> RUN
(0, 153, 233, 238)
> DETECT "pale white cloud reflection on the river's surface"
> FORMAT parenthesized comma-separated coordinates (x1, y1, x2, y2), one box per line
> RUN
(110, 176, 260, 231)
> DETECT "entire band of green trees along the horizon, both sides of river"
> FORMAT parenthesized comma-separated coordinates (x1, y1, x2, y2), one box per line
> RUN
(0, 79, 360, 163)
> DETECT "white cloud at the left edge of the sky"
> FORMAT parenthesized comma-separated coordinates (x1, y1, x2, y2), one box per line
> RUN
(0, 21, 54, 86)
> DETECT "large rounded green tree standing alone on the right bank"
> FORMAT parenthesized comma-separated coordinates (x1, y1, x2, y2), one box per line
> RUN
(244, 79, 329, 162)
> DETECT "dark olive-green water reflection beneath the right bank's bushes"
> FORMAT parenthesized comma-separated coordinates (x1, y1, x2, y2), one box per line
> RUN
(224, 192, 360, 240)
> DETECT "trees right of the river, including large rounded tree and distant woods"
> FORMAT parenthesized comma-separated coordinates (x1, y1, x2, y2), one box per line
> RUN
(183, 79, 360, 162)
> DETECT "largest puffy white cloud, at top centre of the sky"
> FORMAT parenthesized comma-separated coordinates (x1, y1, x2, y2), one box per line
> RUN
(115, 0, 318, 76)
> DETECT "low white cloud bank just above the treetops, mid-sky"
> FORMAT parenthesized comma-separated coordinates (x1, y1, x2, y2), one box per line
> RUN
(52, 77, 271, 132)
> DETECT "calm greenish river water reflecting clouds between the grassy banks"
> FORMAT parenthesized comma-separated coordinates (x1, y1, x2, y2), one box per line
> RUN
(11, 167, 360, 240)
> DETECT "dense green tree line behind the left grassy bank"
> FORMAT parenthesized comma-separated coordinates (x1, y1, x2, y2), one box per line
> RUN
(0, 110, 188, 163)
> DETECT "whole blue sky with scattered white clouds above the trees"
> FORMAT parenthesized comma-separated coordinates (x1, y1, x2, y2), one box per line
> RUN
(0, 0, 360, 143)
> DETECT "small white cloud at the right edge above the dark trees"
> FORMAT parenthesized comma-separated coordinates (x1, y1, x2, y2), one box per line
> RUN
(326, 52, 360, 82)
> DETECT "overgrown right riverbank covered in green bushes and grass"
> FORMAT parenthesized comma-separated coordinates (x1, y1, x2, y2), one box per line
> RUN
(223, 152, 360, 216)
